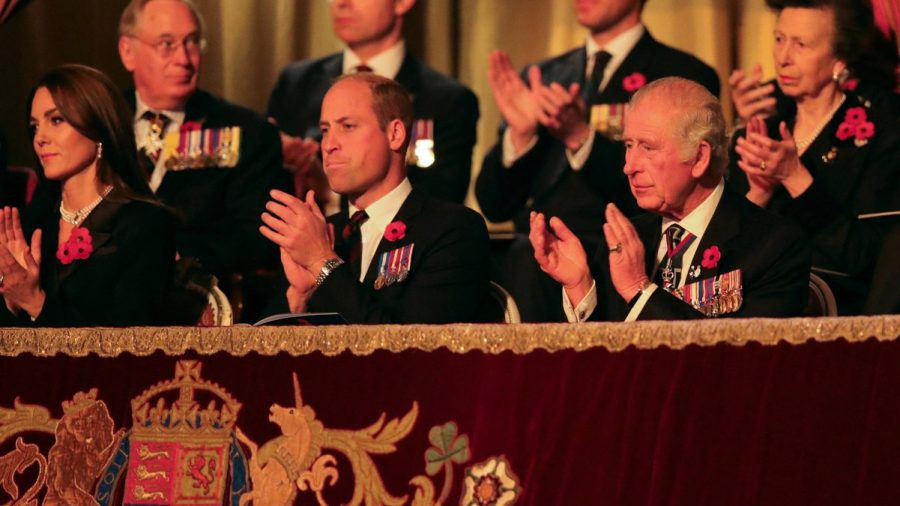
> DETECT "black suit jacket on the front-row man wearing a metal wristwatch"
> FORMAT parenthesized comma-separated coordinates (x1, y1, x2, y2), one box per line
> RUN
(309, 189, 490, 323)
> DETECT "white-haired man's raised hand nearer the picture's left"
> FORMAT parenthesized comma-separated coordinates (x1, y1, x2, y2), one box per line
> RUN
(528, 211, 593, 306)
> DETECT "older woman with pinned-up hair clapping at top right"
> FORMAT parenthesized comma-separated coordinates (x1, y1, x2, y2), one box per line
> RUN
(729, 0, 900, 314)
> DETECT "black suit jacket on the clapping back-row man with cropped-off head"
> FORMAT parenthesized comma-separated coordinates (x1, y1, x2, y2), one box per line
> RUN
(475, 32, 719, 240)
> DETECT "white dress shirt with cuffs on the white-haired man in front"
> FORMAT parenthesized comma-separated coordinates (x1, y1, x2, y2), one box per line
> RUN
(563, 180, 725, 323)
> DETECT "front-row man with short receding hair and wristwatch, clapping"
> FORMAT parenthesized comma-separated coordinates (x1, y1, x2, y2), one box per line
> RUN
(260, 73, 489, 323)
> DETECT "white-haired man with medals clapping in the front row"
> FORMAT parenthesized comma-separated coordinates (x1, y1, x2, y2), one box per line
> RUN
(529, 77, 810, 322)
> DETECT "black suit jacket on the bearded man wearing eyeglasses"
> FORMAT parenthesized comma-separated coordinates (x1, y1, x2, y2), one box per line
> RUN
(125, 90, 282, 276)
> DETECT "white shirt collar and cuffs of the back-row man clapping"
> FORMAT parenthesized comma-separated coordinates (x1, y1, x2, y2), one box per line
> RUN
(502, 23, 644, 171)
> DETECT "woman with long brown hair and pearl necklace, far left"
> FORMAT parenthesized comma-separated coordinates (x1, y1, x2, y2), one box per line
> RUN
(0, 65, 175, 327)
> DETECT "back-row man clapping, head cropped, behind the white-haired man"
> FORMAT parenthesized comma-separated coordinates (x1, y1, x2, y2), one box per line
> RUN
(475, 0, 719, 321)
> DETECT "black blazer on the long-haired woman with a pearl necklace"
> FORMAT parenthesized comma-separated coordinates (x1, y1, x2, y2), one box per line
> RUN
(0, 192, 175, 327)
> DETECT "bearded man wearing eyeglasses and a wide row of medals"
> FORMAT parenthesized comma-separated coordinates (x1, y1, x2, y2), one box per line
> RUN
(118, 0, 282, 280)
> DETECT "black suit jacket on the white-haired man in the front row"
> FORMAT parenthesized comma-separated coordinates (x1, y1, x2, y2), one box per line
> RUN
(590, 190, 810, 321)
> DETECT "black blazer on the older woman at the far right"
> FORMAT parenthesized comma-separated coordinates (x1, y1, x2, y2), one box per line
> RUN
(729, 89, 900, 314)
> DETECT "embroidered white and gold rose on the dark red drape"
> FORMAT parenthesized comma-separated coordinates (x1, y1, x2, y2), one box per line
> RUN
(459, 456, 521, 506)
